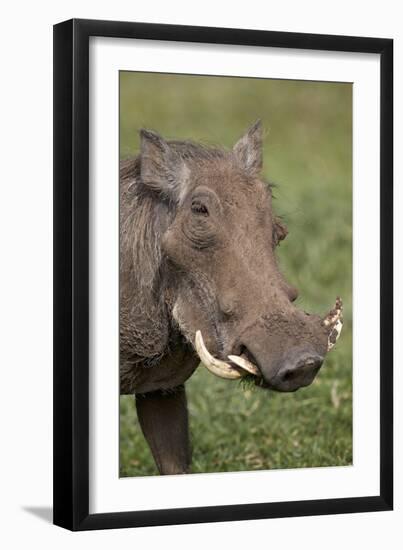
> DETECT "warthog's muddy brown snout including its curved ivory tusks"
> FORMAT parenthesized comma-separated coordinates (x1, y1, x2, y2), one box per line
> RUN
(195, 298, 342, 392)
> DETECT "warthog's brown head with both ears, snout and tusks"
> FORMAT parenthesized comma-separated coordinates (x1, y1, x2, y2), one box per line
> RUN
(140, 122, 342, 391)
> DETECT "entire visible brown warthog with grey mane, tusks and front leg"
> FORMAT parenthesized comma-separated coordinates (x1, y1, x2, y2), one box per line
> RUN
(120, 122, 342, 474)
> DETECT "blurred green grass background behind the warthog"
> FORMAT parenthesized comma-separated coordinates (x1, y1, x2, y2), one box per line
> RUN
(120, 72, 352, 476)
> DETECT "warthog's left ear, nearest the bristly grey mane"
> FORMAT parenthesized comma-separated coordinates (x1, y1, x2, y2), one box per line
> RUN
(140, 130, 187, 200)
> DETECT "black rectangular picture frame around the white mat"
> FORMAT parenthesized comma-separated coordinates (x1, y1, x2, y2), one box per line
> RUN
(54, 19, 393, 530)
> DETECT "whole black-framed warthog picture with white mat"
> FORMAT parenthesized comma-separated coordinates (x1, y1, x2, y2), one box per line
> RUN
(54, 20, 393, 530)
